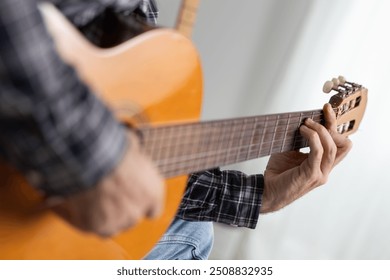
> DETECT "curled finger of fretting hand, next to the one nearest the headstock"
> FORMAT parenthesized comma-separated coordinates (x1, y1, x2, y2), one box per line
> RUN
(305, 119, 337, 175)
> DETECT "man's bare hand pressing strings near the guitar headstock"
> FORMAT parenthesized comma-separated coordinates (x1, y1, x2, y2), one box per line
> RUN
(260, 104, 352, 213)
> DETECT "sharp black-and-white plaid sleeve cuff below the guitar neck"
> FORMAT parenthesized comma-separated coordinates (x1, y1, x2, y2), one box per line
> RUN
(177, 168, 264, 228)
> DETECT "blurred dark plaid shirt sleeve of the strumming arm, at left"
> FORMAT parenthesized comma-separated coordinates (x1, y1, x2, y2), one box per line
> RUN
(0, 0, 128, 195)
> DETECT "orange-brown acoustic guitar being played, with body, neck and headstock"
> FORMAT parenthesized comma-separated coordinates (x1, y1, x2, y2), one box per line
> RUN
(0, 2, 367, 259)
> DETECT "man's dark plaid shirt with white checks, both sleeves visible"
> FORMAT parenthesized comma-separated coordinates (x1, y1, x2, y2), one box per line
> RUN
(0, 0, 263, 228)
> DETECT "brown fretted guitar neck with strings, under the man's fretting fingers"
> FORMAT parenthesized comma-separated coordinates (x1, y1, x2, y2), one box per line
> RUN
(140, 110, 323, 178)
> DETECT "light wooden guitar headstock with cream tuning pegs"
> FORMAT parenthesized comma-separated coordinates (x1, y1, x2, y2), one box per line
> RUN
(323, 76, 367, 135)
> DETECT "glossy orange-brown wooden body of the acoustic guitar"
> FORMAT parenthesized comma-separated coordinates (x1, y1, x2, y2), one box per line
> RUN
(0, 6, 202, 259)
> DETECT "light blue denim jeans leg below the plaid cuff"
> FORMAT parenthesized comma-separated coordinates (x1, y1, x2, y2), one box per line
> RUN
(145, 218, 214, 260)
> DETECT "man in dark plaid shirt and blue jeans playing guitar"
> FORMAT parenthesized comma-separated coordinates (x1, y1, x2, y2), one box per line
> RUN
(0, 0, 351, 259)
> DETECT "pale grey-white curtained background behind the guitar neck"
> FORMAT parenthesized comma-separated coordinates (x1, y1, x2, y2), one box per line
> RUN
(158, 0, 390, 259)
